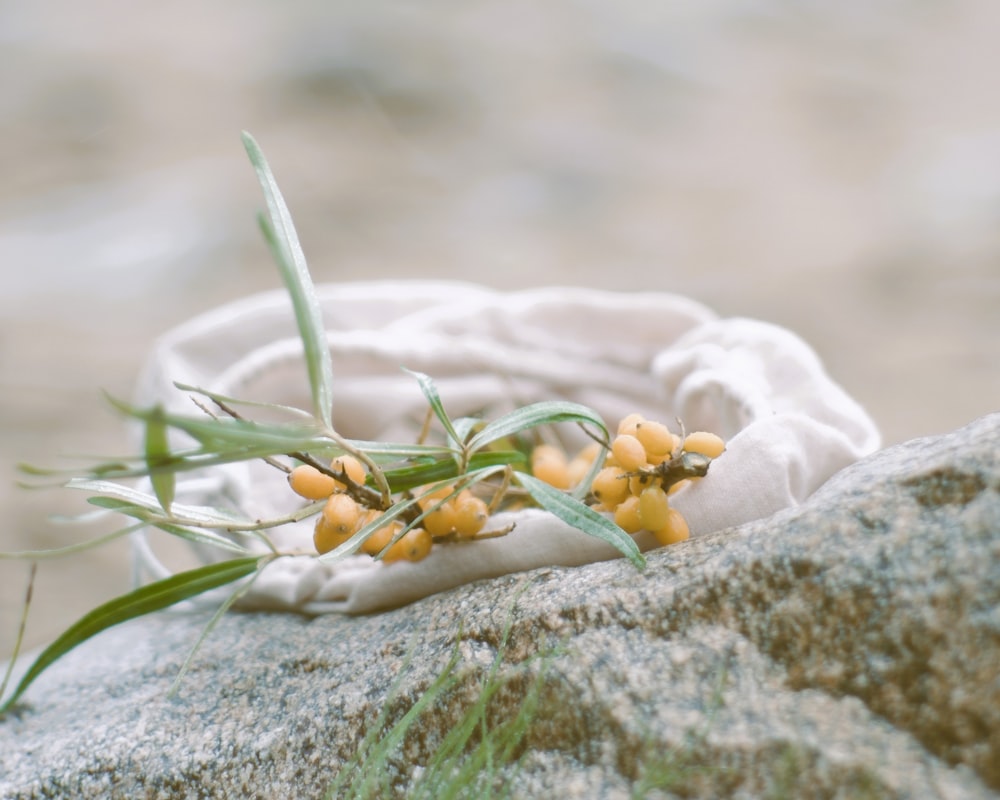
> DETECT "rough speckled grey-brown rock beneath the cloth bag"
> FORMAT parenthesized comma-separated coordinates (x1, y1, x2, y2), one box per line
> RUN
(0, 415, 1000, 798)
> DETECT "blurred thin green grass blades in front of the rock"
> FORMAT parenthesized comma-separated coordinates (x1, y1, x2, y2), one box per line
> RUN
(325, 624, 728, 800)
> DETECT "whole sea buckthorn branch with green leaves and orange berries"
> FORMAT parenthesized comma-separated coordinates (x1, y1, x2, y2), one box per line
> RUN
(0, 134, 724, 716)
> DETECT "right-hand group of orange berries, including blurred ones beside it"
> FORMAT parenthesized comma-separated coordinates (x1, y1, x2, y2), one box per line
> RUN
(531, 414, 725, 545)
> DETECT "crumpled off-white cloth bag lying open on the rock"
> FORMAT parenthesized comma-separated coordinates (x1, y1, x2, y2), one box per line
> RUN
(129, 282, 879, 614)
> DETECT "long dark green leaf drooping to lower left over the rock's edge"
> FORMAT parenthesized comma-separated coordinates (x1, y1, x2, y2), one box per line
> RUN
(0, 556, 261, 714)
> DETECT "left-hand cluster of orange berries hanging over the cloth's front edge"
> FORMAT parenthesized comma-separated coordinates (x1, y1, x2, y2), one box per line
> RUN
(288, 456, 489, 563)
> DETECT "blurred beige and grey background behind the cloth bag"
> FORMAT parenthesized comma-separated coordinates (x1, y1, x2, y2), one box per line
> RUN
(0, 0, 1000, 657)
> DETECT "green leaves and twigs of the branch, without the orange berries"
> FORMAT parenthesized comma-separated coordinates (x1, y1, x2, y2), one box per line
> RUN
(0, 133, 645, 715)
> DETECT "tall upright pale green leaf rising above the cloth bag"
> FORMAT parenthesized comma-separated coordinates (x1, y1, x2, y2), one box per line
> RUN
(243, 131, 333, 428)
